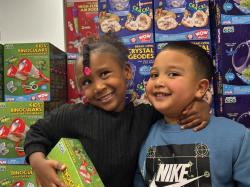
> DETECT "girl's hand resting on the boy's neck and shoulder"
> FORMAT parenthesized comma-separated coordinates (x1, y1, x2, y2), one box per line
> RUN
(179, 100, 211, 131)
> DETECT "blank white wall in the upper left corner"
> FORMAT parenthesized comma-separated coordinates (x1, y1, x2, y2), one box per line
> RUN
(0, 0, 65, 51)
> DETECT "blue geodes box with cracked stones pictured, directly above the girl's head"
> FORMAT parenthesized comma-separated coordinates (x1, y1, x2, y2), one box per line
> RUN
(98, 0, 154, 44)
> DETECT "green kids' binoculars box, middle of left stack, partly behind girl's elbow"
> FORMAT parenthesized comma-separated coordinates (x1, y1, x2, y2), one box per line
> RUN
(0, 102, 44, 164)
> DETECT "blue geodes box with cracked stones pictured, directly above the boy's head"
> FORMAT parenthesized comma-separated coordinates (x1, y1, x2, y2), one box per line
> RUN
(154, 0, 210, 42)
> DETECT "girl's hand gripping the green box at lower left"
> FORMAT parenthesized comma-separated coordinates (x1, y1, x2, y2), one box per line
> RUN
(30, 152, 66, 187)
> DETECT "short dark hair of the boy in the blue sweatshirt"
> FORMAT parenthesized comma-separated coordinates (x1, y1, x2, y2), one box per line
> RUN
(161, 41, 214, 81)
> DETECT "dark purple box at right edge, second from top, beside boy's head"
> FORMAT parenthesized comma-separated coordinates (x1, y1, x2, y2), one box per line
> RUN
(216, 25, 250, 95)
